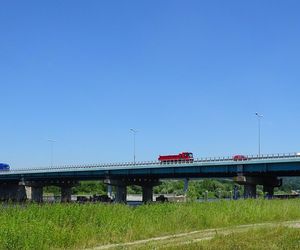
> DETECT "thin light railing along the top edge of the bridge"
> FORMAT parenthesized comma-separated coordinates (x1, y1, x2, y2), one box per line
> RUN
(1, 153, 300, 174)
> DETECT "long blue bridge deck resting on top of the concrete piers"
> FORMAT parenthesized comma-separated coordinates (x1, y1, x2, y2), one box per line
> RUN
(0, 154, 300, 181)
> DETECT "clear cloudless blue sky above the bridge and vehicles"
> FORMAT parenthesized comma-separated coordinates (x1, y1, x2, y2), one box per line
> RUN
(0, 0, 300, 168)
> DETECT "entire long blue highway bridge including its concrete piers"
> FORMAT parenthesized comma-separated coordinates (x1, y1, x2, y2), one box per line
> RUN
(0, 153, 300, 202)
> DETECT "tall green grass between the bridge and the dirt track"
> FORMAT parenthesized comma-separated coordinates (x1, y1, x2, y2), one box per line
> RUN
(0, 200, 300, 249)
